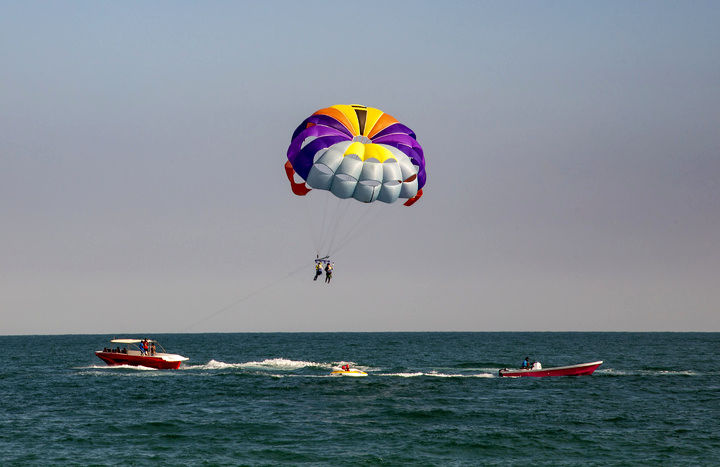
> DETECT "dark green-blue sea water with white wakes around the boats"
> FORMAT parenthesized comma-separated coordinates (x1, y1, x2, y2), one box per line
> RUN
(0, 333, 720, 466)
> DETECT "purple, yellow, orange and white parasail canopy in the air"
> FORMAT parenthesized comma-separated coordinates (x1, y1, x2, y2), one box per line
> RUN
(285, 105, 426, 206)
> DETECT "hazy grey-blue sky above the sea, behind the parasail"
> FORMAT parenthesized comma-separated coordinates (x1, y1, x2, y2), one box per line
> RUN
(0, 0, 720, 335)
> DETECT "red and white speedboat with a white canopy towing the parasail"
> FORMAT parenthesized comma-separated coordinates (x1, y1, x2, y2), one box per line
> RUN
(95, 339, 189, 370)
